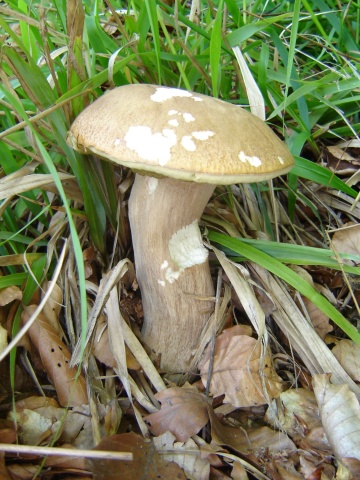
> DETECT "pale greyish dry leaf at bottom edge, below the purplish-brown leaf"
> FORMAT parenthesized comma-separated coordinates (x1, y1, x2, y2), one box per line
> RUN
(153, 432, 210, 480)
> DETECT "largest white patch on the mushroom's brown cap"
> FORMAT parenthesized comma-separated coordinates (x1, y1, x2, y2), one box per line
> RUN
(124, 126, 177, 165)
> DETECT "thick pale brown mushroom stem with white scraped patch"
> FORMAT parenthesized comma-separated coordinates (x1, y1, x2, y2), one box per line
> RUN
(129, 174, 215, 378)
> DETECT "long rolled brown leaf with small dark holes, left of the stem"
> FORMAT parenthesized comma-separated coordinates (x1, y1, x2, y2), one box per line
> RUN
(21, 305, 88, 407)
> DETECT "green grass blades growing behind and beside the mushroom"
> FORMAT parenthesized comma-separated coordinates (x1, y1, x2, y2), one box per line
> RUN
(0, 0, 360, 472)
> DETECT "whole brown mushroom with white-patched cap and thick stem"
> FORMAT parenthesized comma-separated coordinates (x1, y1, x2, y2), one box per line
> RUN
(67, 85, 294, 374)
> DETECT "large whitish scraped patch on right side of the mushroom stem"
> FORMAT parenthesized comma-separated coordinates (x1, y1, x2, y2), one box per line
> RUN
(169, 220, 209, 270)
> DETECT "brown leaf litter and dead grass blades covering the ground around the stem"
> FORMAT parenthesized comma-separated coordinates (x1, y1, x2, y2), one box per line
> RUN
(0, 9, 360, 480)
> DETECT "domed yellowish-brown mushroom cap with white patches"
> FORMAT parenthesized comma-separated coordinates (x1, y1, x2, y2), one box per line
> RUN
(67, 84, 294, 185)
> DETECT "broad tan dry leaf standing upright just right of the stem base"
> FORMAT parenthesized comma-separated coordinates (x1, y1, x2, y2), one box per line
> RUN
(200, 328, 281, 407)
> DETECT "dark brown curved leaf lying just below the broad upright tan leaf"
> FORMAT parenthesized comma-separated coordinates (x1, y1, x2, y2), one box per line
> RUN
(208, 406, 296, 455)
